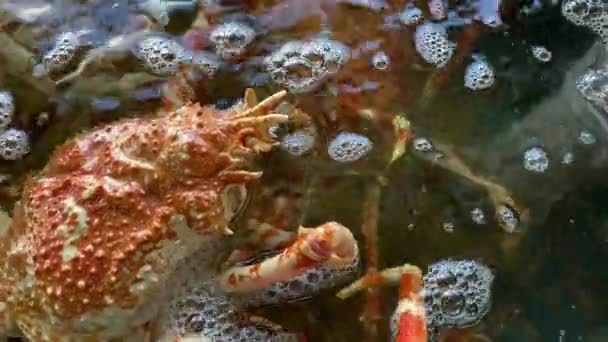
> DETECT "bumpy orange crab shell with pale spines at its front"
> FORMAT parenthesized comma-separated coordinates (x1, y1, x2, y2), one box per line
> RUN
(0, 92, 287, 338)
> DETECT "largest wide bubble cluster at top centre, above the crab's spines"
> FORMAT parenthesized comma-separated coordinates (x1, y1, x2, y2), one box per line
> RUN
(265, 38, 350, 93)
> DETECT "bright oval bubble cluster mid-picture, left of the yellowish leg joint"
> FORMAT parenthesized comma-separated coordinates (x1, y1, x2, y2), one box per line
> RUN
(327, 132, 374, 163)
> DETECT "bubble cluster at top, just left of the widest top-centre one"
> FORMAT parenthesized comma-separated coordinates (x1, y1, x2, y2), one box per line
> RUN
(134, 35, 192, 76)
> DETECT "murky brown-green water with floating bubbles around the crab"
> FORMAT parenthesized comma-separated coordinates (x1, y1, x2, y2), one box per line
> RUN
(0, 0, 608, 342)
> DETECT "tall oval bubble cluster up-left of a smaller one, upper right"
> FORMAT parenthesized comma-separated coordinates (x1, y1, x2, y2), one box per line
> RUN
(414, 22, 456, 68)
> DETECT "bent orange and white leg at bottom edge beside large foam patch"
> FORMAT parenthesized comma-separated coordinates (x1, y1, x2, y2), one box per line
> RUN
(337, 264, 427, 342)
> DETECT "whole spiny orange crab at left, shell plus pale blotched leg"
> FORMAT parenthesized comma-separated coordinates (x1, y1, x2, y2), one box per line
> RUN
(0, 89, 358, 341)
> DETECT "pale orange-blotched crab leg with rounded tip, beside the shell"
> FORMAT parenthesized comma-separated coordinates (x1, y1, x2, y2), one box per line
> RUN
(218, 222, 357, 292)
